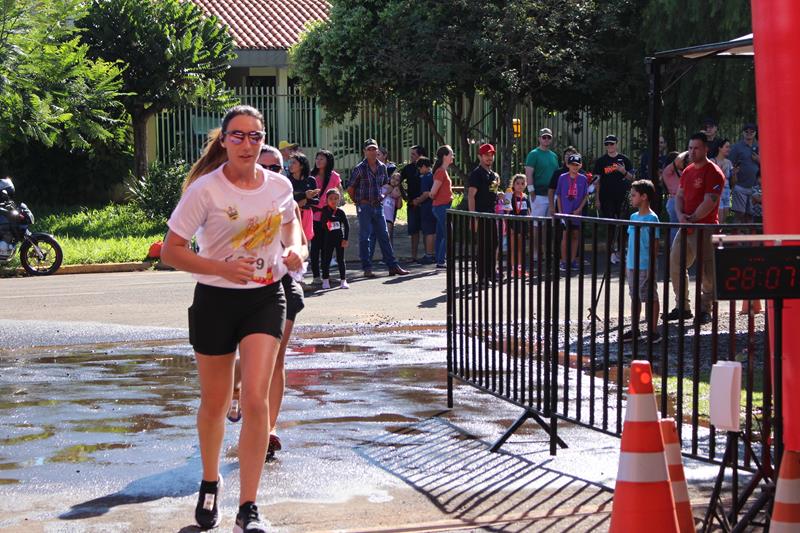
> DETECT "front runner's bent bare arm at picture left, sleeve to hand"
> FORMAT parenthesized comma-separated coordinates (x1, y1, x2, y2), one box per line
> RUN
(161, 230, 255, 285)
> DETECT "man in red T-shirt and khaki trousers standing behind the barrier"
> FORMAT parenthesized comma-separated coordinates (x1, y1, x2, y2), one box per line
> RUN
(665, 132, 725, 324)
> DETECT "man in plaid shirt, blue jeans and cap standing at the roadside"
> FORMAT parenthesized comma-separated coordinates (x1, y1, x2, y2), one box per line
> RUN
(347, 139, 408, 278)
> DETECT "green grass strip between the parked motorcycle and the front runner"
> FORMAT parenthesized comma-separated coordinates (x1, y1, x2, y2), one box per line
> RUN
(0, 204, 167, 270)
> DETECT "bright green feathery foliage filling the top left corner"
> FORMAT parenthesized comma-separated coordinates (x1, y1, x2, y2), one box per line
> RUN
(0, 0, 125, 154)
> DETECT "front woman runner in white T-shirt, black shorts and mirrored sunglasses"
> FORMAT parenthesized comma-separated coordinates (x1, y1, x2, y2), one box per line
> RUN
(162, 106, 307, 532)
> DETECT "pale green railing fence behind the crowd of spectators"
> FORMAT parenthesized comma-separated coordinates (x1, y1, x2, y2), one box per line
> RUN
(156, 87, 645, 181)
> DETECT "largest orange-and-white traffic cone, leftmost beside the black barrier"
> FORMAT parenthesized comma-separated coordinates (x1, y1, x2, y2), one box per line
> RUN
(609, 361, 679, 533)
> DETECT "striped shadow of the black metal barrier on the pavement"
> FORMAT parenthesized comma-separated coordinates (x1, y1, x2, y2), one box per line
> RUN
(356, 416, 613, 531)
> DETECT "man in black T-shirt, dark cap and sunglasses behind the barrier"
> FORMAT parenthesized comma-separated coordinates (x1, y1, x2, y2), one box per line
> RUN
(594, 135, 634, 265)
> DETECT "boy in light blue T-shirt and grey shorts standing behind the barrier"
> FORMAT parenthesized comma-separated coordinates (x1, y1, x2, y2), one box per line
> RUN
(622, 180, 661, 343)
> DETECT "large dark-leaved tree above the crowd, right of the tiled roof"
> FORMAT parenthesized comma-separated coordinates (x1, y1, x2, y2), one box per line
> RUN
(290, 0, 643, 180)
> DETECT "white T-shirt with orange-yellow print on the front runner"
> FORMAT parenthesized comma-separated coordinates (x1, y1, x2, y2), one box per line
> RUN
(167, 164, 294, 289)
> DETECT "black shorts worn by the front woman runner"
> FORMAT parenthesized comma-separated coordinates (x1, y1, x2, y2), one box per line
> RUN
(189, 283, 286, 355)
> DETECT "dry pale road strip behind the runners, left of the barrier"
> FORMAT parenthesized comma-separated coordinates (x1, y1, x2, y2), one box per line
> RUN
(0, 266, 446, 328)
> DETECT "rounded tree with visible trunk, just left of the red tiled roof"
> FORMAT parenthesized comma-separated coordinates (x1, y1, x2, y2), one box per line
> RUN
(77, 0, 235, 177)
